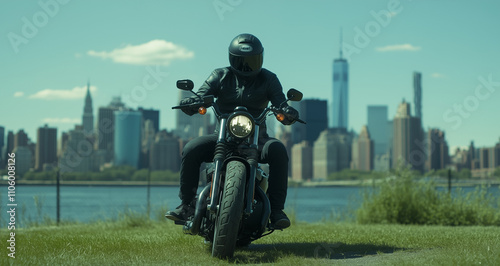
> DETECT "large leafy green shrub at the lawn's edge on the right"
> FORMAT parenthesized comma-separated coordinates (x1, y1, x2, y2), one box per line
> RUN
(356, 167, 500, 226)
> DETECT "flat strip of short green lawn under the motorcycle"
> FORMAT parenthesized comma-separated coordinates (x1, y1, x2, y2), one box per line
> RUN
(0, 219, 500, 265)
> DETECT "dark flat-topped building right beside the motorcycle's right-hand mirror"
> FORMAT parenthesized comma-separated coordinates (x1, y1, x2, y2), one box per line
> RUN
(292, 99, 328, 143)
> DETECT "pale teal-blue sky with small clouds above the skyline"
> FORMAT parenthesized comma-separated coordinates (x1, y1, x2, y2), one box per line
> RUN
(0, 0, 500, 150)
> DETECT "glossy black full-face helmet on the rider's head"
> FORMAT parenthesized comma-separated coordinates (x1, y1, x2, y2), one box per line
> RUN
(229, 33, 264, 77)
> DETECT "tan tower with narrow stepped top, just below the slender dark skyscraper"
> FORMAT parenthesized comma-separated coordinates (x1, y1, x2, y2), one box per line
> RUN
(392, 100, 426, 171)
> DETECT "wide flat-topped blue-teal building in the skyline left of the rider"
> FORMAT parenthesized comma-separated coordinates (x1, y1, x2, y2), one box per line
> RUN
(114, 110, 142, 168)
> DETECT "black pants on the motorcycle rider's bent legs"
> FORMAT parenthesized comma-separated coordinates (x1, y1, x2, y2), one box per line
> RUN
(179, 134, 288, 210)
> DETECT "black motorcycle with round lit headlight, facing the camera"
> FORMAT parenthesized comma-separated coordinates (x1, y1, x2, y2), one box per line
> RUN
(172, 80, 305, 258)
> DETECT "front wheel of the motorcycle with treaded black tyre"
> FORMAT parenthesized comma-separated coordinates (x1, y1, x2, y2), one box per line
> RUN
(212, 161, 246, 258)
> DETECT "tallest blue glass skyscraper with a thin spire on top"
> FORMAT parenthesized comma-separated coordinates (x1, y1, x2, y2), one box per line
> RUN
(331, 31, 349, 129)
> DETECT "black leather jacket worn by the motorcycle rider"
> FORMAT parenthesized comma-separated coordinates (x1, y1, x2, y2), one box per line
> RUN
(197, 67, 286, 136)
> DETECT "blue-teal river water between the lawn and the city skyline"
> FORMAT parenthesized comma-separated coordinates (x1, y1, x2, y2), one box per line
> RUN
(0, 185, 500, 225)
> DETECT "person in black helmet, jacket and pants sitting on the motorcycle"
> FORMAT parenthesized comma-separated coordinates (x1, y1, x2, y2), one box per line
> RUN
(165, 34, 298, 229)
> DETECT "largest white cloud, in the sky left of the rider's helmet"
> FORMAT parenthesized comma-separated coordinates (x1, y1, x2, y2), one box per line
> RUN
(87, 40, 194, 65)
